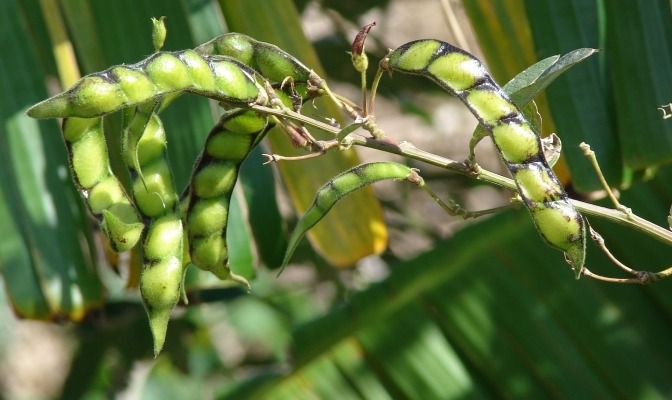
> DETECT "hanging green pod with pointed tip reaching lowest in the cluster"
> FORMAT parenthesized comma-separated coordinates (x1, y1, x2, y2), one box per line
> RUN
(122, 104, 184, 355)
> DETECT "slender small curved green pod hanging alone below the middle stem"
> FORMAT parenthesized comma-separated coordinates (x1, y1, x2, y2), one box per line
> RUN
(280, 162, 414, 272)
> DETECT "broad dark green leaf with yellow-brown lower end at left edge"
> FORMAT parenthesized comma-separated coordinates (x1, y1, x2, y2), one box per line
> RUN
(0, 3, 104, 320)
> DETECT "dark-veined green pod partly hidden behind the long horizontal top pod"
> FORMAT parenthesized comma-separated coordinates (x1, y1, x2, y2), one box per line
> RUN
(194, 32, 311, 83)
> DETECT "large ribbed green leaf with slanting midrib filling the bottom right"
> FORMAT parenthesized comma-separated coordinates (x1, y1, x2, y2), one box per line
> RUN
(222, 170, 672, 399)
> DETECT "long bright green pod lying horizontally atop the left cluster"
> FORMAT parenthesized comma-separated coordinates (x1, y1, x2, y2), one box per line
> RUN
(27, 50, 266, 118)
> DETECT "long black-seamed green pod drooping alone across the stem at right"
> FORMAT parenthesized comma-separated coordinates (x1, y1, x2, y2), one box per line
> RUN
(380, 40, 586, 279)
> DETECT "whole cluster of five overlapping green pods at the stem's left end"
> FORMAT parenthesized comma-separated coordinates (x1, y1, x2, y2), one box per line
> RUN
(28, 33, 326, 353)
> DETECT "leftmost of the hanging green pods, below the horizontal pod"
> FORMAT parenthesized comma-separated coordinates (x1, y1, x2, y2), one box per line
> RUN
(62, 118, 144, 252)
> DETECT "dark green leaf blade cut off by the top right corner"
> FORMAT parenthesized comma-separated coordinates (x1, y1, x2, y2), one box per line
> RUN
(590, 0, 672, 169)
